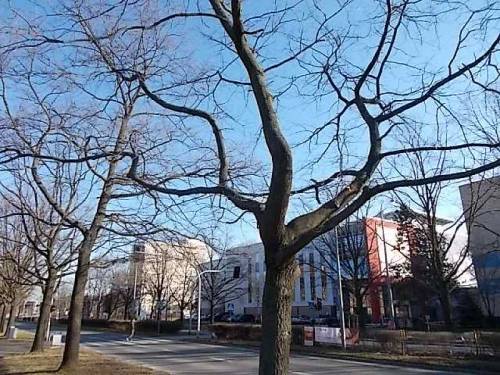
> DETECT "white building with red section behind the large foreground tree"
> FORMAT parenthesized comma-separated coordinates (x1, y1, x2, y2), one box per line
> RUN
(225, 217, 402, 323)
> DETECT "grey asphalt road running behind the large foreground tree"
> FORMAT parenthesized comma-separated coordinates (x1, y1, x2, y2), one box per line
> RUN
(75, 332, 464, 375)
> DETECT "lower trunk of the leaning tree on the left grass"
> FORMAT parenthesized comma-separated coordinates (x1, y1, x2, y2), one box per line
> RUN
(60, 241, 94, 370)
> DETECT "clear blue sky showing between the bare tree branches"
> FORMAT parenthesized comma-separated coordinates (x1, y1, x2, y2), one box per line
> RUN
(0, 0, 498, 250)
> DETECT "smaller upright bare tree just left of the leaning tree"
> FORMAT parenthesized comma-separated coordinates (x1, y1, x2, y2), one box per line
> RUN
(2, 165, 81, 352)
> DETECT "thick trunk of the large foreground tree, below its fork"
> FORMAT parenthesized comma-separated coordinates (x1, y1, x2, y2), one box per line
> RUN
(259, 260, 297, 375)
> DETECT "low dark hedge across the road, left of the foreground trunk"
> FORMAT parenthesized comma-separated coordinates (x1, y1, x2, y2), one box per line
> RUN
(58, 319, 182, 333)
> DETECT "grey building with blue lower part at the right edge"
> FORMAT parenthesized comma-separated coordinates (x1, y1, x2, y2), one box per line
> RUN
(460, 177, 500, 317)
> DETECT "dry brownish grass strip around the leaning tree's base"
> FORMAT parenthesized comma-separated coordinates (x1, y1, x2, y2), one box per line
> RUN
(0, 348, 165, 375)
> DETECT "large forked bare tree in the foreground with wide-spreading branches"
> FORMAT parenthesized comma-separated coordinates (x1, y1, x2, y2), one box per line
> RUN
(3, 0, 500, 374)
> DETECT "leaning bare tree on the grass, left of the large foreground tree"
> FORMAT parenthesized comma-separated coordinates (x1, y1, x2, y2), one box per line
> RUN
(1, 40, 148, 368)
